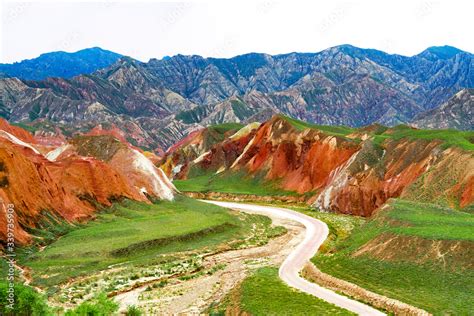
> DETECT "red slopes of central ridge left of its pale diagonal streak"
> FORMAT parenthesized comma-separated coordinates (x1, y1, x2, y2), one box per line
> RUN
(164, 116, 359, 194)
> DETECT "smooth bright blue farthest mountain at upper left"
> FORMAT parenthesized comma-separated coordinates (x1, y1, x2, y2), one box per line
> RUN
(0, 47, 122, 80)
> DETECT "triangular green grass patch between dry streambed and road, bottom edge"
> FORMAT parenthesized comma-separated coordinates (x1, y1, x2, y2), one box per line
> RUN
(211, 267, 352, 316)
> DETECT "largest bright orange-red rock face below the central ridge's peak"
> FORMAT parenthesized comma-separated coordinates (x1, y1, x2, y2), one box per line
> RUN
(233, 116, 359, 194)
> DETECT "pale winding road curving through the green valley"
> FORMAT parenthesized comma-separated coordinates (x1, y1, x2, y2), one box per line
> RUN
(203, 200, 385, 315)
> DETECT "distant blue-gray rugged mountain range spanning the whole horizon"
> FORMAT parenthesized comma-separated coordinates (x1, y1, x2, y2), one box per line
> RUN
(0, 45, 474, 149)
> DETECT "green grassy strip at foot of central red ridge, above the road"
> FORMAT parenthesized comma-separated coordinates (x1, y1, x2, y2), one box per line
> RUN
(173, 171, 296, 196)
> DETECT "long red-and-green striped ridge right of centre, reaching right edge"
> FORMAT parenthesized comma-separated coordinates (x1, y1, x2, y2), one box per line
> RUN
(162, 116, 474, 216)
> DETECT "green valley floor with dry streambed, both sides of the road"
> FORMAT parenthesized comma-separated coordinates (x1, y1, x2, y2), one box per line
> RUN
(2, 196, 474, 315)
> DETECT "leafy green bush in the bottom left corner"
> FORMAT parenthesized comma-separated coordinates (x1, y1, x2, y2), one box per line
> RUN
(0, 281, 53, 316)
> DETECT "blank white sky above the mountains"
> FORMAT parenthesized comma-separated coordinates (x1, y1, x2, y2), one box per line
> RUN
(0, 0, 474, 63)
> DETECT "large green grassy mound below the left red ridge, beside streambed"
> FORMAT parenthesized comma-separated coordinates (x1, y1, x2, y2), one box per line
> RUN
(21, 196, 262, 287)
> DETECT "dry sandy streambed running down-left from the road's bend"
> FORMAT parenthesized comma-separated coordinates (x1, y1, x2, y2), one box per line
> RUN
(115, 210, 304, 315)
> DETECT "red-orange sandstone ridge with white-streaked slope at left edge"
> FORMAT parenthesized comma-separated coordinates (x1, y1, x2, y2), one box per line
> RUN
(0, 121, 175, 244)
